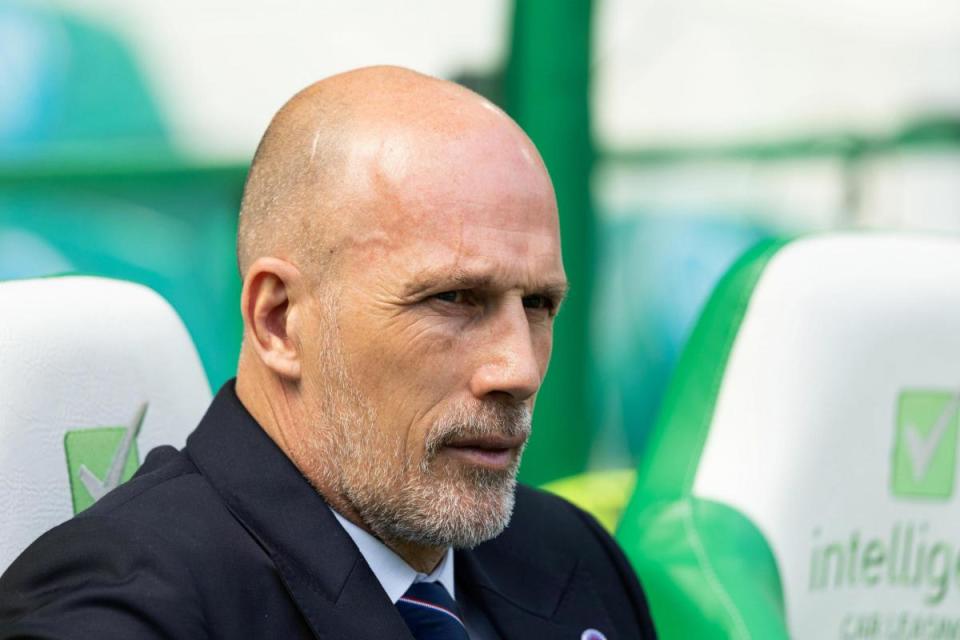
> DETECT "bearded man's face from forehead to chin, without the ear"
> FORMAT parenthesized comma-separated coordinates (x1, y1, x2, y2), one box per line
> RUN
(303, 117, 566, 547)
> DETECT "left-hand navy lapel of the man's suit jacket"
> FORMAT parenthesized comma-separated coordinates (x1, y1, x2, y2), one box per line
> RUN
(186, 383, 412, 640)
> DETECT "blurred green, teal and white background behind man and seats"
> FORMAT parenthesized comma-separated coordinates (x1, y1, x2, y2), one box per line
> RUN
(0, 0, 960, 483)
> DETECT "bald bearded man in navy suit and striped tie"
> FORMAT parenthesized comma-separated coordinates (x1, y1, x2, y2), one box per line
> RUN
(0, 67, 653, 640)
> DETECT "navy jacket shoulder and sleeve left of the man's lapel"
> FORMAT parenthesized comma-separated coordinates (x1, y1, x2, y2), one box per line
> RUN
(0, 447, 301, 638)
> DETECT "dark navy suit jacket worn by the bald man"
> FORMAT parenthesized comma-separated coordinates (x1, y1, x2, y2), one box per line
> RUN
(0, 384, 654, 640)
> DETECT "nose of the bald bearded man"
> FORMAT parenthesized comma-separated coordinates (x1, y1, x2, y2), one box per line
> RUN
(470, 300, 543, 402)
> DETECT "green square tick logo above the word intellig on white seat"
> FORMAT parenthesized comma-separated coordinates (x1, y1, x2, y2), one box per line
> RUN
(893, 391, 960, 500)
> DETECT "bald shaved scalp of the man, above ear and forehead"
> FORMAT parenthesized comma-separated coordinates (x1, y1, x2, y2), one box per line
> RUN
(237, 67, 546, 276)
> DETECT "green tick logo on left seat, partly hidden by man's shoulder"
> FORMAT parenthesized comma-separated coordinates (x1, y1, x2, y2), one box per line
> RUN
(63, 404, 147, 513)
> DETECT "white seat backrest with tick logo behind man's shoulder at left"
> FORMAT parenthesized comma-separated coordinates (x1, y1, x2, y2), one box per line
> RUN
(0, 276, 210, 573)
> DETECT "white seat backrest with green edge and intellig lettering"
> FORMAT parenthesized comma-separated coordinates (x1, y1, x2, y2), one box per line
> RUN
(621, 233, 960, 639)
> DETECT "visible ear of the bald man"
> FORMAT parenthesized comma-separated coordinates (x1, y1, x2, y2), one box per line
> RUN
(240, 258, 304, 381)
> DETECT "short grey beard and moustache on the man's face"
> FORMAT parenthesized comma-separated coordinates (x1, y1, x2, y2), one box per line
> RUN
(294, 300, 531, 548)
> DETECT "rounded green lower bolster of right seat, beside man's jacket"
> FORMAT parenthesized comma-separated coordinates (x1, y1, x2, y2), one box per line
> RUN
(617, 496, 789, 640)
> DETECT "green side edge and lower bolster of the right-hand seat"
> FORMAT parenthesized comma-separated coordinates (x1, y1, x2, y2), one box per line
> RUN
(617, 241, 787, 640)
